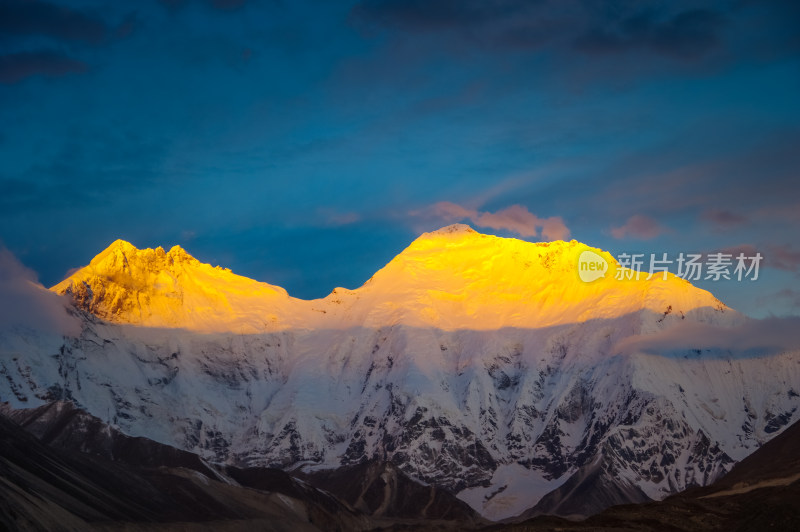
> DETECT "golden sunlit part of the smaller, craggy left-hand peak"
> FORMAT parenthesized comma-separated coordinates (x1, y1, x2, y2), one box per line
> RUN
(51, 240, 288, 332)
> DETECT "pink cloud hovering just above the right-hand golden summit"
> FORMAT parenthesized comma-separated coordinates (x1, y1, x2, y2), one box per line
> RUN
(422, 201, 570, 240)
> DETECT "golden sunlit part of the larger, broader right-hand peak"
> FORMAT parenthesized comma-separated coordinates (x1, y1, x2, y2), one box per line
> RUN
(346, 229, 736, 330)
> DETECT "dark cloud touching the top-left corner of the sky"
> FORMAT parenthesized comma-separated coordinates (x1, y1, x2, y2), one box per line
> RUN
(0, 0, 114, 45)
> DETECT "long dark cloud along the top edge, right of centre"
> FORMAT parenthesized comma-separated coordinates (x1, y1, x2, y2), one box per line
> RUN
(352, 0, 726, 59)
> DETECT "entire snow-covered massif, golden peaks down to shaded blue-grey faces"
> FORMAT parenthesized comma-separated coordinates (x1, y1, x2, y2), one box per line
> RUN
(0, 225, 800, 518)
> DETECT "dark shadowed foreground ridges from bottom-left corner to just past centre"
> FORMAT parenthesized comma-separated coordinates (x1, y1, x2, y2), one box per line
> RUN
(0, 402, 481, 530)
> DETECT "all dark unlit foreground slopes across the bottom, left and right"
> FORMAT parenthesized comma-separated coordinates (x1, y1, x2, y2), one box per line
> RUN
(0, 403, 800, 532)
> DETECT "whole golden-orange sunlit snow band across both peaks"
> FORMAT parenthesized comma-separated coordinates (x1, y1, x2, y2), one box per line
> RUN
(51, 224, 726, 333)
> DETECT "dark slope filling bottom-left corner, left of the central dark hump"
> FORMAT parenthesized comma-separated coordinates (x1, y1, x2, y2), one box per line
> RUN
(0, 403, 368, 532)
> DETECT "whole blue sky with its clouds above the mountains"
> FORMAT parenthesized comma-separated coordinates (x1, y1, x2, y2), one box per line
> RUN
(0, 0, 800, 316)
